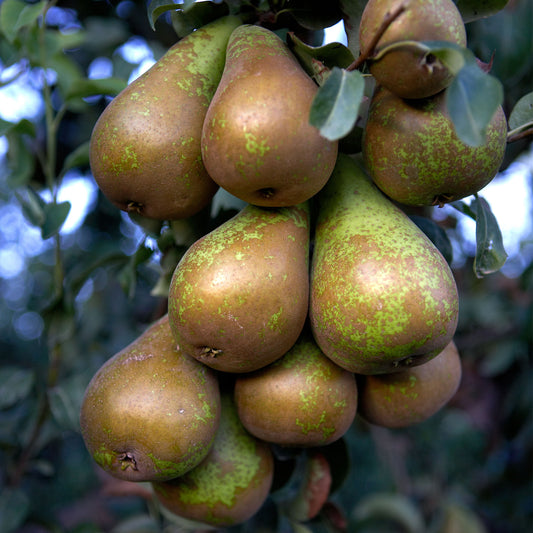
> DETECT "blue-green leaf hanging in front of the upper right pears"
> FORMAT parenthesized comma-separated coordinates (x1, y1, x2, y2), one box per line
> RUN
(446, 54, 503, 146)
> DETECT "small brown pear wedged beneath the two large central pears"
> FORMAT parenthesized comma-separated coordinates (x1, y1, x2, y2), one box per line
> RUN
(235, 331, 357, 447)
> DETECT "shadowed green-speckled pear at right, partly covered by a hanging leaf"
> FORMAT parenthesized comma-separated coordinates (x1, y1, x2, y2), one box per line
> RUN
(362, 88, 507, 206)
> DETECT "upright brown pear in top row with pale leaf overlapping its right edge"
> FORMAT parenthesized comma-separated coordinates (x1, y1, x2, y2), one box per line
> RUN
(202, 24, 338, 207)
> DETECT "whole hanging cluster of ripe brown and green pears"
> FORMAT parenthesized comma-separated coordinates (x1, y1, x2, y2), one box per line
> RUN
(80, 0, 508, 527)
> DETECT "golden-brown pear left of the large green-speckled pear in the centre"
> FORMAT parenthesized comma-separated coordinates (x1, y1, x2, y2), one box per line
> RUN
(168, 203, 310, 373)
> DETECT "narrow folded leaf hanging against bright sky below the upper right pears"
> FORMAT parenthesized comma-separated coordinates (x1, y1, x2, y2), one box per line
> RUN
(472, 196, 507, 278)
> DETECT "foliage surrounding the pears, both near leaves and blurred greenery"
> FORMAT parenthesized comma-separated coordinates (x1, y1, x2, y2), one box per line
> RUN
(0, 0, 533, 533)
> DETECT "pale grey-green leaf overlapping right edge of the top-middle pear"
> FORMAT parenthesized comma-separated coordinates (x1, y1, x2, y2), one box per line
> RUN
(309, 67, 365, 141)
